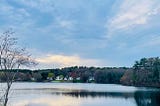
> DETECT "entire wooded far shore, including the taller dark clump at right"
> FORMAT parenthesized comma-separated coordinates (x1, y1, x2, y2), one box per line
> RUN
(0, 57, 160, 87)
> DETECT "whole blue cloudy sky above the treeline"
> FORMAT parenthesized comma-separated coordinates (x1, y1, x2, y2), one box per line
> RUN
(0, 0, 160, 68)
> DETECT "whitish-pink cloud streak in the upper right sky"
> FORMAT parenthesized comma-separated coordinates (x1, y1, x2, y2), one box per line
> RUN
(107, 0, 160, 32)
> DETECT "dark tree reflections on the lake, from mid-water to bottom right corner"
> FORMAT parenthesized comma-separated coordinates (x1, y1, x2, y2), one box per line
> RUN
(53, 91, 160, 106)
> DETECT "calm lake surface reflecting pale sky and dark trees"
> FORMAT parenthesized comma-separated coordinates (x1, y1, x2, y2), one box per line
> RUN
(3, 83, 160, 106)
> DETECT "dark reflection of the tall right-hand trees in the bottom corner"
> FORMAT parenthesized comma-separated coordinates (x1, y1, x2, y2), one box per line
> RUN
(134, 92, 160, 106)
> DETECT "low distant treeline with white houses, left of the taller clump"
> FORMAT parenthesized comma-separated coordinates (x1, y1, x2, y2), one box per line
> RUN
(0, 66, 128, 84)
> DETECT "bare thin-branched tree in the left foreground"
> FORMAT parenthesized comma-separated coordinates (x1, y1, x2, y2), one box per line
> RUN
(0, 30, 36, 106)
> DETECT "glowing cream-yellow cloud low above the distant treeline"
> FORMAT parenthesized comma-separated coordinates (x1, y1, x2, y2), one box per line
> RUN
(36, 54, 102, 67)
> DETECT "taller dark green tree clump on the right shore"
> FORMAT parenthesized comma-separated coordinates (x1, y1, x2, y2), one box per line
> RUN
(121, 57, 160, 87)
